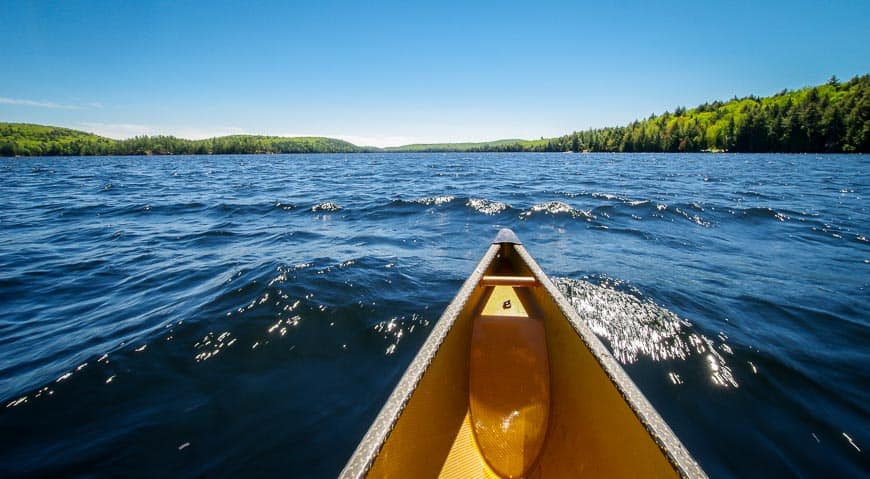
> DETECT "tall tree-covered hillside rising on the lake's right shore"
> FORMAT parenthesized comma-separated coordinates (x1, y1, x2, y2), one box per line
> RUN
(544, 75, 870, 153)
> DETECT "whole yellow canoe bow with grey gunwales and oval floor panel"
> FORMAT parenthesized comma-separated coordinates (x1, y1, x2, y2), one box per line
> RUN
(340, 230, 706, 479)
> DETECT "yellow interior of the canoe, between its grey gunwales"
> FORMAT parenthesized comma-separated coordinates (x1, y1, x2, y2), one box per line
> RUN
(354, 244, 696, 478)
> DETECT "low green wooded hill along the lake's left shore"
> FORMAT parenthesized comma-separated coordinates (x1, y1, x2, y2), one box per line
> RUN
(0, 123, 373, 156)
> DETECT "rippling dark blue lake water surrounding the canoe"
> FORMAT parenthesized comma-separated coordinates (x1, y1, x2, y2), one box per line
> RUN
(0, 154, 870, 478)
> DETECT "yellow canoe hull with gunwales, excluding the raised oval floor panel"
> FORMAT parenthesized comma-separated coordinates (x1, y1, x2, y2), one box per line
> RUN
(341, 233, 706, 478)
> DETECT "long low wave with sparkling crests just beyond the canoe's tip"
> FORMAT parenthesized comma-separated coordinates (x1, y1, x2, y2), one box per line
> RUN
(39, 192, 812, 236)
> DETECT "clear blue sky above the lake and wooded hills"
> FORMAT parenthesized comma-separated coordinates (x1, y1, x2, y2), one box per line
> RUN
(0, 0, 870, 146)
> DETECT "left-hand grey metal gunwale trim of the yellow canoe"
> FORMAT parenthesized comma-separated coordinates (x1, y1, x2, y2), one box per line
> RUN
(338, 244, 509, 479)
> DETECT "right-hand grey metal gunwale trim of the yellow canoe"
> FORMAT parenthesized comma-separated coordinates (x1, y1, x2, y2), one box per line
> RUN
(514, 244, 707, 479)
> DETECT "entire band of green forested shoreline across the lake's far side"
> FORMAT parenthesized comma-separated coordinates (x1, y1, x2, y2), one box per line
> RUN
(0, 75, 870, 156)
